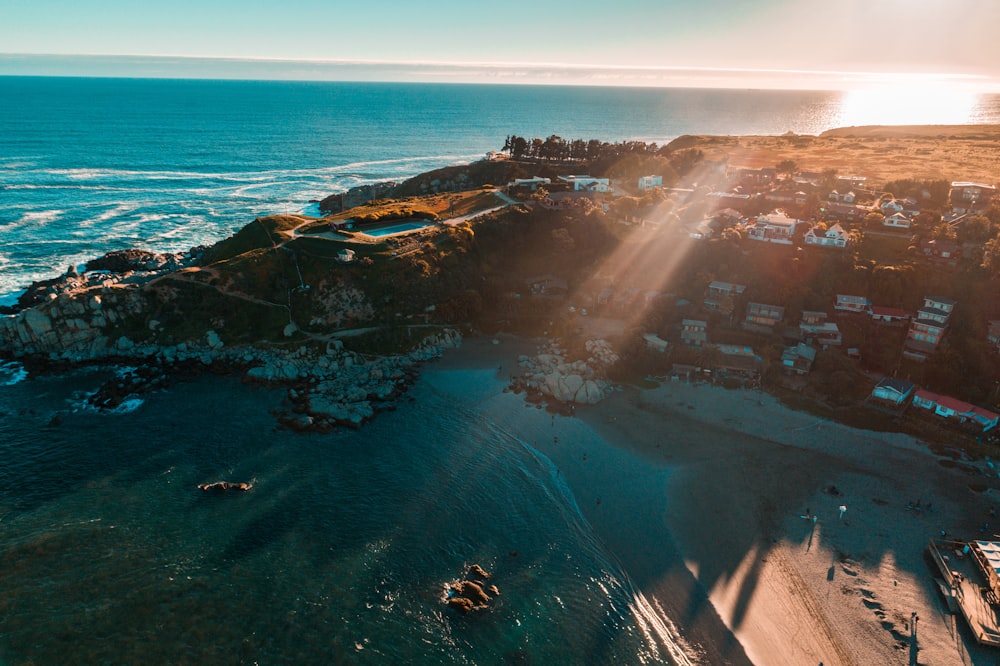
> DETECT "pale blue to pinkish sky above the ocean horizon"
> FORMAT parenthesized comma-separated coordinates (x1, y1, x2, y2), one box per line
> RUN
(0, 0, 1000, 89)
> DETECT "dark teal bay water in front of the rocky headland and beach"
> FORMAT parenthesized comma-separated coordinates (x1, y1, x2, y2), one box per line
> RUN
(0, 372, 688, 664)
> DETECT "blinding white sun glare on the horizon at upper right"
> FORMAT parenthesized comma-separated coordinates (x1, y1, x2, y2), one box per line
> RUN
(836, 81, 979, 127)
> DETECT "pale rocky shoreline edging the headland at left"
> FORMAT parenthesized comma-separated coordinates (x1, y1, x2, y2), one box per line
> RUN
(0, 246, 462, 432)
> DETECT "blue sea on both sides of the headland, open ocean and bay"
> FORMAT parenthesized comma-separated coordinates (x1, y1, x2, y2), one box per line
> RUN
(0, 77, 1000, 664)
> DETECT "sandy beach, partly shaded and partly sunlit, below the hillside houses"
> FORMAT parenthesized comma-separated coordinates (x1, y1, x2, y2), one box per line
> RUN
(423, 337, 1000, 666)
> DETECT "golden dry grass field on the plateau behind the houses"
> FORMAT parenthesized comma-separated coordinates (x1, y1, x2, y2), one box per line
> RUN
(685, 125, 1000, 185)
